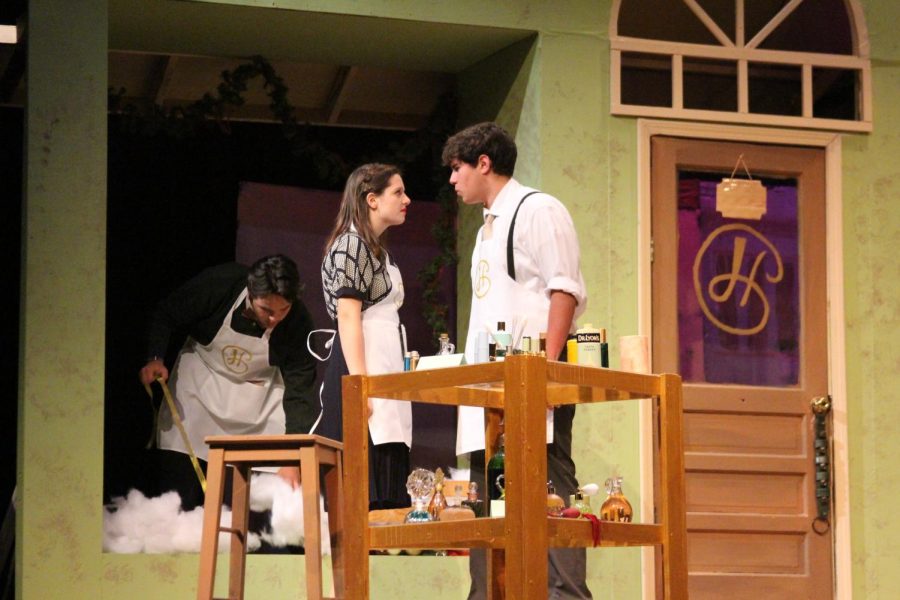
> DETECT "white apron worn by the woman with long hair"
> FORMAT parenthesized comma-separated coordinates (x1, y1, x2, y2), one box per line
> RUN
(362, 260, 412, 447)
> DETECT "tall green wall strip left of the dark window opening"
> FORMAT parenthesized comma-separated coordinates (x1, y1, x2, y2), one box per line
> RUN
(16, 0, 107, 598)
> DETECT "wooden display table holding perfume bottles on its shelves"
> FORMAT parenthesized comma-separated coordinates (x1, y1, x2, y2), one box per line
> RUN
(343, 355, 687, 600)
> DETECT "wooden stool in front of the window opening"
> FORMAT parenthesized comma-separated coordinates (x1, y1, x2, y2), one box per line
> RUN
(197, 435, 344, 600)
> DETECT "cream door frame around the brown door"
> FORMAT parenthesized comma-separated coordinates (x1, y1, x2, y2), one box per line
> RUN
(637, 119, 853, 600)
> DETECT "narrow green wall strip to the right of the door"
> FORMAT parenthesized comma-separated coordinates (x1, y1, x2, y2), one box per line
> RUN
(843, 0, 900, 598)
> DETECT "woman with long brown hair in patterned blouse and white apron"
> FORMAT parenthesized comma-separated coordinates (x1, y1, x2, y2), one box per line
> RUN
(315, 163, 412, 510)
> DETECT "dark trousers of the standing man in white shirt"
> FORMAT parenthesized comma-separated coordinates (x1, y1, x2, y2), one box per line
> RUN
(469, 404, 593, 600)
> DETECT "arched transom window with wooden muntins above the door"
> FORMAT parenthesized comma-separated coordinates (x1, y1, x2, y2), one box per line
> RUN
(610, 0, 872, 131)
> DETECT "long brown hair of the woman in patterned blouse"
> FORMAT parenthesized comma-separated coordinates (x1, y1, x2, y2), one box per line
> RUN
(325, 163, 400, 260)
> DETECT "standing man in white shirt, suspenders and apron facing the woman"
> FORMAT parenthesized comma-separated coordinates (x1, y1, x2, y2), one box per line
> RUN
(442, 123, 592, 600)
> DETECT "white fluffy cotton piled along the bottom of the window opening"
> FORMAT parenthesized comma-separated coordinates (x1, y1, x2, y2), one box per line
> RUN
(103, 473, 331, 554)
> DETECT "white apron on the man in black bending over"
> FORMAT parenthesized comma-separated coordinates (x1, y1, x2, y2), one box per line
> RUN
(158, 289, 285, 460)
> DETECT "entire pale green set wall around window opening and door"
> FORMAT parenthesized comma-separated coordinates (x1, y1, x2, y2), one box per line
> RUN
(17, 0, 900, 600)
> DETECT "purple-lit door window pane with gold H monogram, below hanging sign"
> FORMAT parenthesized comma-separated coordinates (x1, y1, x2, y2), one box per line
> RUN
(678, 172, 801, 387)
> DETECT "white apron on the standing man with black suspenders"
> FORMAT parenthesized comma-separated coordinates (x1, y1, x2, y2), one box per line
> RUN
(456, 213, 550, 454)
